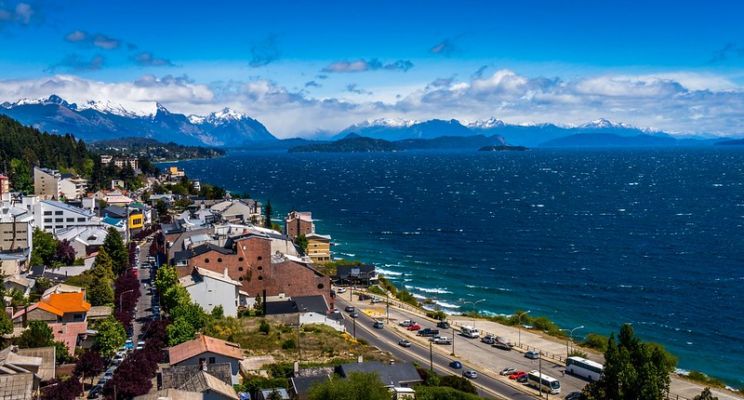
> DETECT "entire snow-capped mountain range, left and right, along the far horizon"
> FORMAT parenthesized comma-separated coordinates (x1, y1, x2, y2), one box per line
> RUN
(0, 95, 740, 149)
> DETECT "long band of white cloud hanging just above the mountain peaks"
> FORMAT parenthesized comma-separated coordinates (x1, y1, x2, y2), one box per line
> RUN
(0, 70, 744, 137)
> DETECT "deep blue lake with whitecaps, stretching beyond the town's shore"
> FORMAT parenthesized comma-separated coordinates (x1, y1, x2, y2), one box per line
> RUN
(161, 148, 744, 386)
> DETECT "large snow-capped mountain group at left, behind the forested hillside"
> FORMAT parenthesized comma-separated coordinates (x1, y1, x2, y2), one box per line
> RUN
(0, 95, 276, 147)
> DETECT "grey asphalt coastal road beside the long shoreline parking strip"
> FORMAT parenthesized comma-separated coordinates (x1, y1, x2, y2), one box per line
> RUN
(336, 297, 536, 400)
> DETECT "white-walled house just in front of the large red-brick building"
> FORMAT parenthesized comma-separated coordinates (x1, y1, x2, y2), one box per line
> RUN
(179, 267, 241, 317)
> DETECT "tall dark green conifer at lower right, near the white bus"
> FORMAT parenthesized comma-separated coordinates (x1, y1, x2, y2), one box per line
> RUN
(584, 324, 676, 400)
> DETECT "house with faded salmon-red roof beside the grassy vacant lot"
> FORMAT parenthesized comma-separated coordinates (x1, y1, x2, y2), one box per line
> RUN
(168, 334, 243, 385)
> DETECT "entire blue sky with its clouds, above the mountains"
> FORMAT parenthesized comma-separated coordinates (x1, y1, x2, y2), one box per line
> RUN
(0, 0, 744, 137)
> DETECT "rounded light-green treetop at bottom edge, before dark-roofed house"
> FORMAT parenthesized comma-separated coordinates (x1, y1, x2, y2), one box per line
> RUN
(308, 372, 390, 400)
